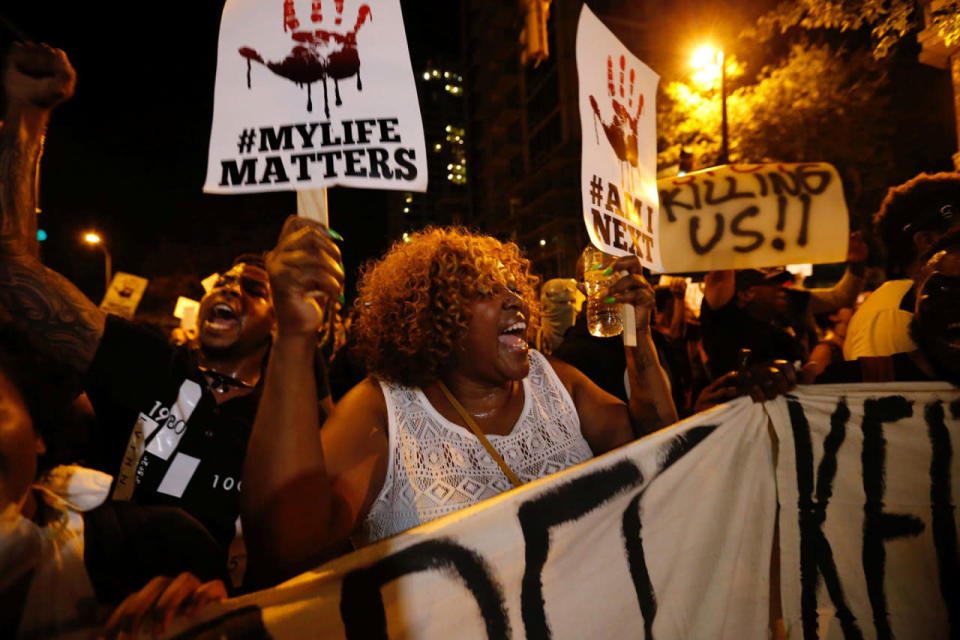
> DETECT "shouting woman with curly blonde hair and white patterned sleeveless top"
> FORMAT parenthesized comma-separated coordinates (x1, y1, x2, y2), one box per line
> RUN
(241, 222, 676, 581)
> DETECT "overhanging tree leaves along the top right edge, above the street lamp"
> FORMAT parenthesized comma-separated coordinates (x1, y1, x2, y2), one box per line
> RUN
(754, 0, 960, 59)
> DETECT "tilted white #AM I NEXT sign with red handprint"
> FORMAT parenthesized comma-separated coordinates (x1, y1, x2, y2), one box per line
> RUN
(577, 4, 661, 271)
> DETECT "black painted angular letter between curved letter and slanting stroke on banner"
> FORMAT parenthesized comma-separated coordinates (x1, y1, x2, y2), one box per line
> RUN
(517, 460, 643, 640)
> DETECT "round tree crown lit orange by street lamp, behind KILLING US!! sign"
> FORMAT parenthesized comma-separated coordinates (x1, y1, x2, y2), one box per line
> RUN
(657, 43, 894, 218)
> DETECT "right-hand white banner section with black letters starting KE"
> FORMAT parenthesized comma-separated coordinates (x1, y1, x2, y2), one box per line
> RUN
(770, 383, 960, 640)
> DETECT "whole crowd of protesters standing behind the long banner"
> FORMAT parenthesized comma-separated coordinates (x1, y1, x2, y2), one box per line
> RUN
(0, 45, 960, 638)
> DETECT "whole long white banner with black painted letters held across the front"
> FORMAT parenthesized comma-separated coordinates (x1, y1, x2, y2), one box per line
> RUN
(161, 383, 960, 640)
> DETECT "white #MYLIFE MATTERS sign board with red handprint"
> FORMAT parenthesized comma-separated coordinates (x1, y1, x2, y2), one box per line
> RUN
(203, 0, 427, 193)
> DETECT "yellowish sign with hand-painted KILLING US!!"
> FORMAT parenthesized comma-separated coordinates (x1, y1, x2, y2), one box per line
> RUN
(657, 162, 849, 272)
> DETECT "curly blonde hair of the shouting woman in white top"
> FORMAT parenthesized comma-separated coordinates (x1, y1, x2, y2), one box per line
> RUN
(353, 227, 539, 387)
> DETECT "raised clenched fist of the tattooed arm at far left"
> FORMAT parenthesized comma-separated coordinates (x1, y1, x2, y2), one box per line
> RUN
(3, 42, 77, 109)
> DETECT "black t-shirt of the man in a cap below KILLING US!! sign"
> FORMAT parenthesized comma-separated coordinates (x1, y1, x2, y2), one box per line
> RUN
(700, 289, 810, 378)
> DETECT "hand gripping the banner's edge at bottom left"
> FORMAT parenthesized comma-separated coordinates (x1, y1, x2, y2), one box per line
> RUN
(101, 573, 227, 638)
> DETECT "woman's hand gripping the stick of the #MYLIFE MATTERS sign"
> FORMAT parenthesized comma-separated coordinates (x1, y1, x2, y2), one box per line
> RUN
(266, 216, 344, 335)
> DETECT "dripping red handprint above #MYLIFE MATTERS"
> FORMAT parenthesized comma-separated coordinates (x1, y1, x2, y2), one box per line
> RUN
(239, 0, 372, 118)
